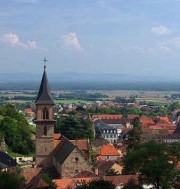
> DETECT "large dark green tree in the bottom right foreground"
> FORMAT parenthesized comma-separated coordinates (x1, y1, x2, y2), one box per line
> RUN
(123, 141, 178, 189)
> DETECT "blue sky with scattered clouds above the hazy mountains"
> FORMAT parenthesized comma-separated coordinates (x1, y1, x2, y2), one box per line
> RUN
(0, 0, 180, 79)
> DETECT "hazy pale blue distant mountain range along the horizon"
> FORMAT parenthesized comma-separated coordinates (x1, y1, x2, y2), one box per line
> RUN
(0, 72, 180, 82)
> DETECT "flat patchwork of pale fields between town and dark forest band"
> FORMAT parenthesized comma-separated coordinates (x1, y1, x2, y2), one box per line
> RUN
(0, 90, 180, 104)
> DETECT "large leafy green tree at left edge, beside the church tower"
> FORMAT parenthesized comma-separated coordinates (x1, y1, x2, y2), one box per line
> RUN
(0, 104, 33, 154)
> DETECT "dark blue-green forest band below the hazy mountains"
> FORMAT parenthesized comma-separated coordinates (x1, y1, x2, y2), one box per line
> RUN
(0, 80, 180, 91)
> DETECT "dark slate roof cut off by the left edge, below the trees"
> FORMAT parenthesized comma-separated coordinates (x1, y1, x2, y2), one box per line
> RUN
(0, 151, 17, 168)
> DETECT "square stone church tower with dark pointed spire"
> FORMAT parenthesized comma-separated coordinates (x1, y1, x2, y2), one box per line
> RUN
(35, 64, 56, 168)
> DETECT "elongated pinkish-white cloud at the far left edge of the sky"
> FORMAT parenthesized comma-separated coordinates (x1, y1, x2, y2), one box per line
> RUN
(0, 33, 37, 49)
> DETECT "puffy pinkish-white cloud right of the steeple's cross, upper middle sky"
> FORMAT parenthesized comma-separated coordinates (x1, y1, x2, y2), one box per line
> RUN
(62, 33, 83, 51)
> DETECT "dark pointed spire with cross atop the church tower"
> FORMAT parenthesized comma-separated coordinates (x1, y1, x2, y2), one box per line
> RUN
(35, 58, 54, 104)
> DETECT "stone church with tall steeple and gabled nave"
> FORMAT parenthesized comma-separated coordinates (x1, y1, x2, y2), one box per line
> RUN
(35, 66, 92, 178)
